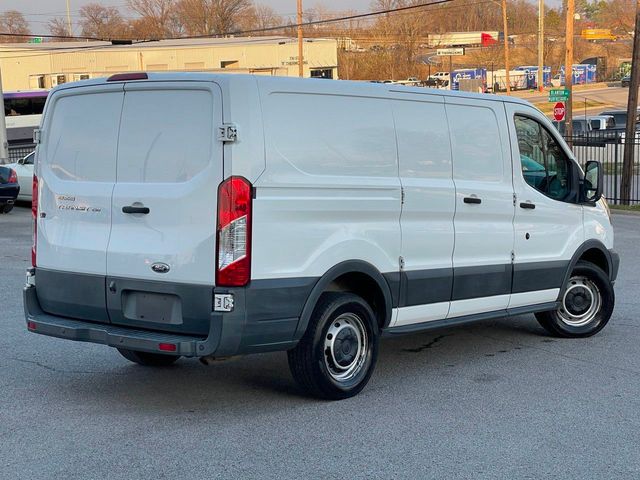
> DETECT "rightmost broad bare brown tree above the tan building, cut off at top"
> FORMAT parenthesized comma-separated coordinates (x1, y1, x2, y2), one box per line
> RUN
(177, 0, 252, 35)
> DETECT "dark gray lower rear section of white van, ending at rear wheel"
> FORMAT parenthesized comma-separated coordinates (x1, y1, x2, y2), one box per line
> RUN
(24, 269, 317, 356)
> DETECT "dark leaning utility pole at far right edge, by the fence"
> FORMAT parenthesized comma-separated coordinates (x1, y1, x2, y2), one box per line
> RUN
(620, 0, 640, 205)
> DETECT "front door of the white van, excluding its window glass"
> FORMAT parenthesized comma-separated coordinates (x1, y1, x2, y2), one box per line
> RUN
(505, 102, 588, 307)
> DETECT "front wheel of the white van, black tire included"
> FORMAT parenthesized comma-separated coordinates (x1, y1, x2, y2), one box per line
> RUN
(536, 260, 615, 338)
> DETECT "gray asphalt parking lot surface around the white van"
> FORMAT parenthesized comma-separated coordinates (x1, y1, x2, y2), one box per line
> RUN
(0, 207, 640, 479)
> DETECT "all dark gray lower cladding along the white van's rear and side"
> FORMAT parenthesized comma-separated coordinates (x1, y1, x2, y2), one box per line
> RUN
(24, 251, 619, 356)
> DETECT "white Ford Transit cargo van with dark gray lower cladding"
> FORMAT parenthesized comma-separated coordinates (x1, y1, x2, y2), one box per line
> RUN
(24, 73, 619, 399)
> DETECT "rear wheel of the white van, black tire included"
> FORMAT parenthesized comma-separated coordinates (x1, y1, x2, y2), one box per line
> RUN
(287, 293, 380, 400)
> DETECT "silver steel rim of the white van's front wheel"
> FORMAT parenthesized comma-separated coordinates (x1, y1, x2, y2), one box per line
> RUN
(558, 276, 602, 327)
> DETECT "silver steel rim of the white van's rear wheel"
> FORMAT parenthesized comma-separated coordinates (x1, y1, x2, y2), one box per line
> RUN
(324, 313, 369, 382)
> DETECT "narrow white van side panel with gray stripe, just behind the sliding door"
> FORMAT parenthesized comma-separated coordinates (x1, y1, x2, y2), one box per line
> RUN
(391, 95, 455, 326)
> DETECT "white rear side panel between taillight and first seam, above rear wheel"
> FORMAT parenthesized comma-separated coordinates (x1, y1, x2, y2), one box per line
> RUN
(252, 78, 401, 280)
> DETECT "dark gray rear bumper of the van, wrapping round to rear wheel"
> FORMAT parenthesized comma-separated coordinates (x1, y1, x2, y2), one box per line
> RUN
(23, 269, 317, 357)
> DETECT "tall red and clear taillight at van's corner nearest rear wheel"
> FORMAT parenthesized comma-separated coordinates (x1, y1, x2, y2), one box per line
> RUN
(216, 177, 252, 287)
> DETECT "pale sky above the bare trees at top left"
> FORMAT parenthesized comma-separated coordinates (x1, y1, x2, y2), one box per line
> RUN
(0, 0, 371, 34)
